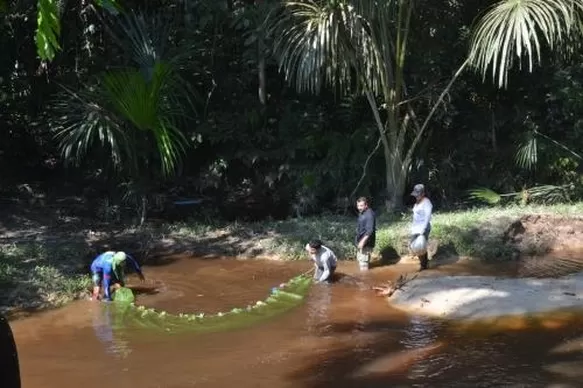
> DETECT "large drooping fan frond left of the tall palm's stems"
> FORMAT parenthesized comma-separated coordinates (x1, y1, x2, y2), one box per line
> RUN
(270, 0, 392, 93)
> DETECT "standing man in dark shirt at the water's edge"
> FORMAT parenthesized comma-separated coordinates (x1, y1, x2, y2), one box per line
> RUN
(356, 197, 376, 271)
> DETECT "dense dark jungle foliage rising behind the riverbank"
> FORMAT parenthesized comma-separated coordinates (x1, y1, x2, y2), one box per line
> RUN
(0, 0, 583, 220)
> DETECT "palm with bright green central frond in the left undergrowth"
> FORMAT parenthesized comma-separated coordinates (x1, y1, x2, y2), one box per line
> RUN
(53, 13, 192, 223)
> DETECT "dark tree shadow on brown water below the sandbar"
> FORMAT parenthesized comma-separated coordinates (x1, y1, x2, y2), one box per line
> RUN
(288, 306, 583, 388)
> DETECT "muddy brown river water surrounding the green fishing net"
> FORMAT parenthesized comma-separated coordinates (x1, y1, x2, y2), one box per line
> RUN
(11, 258, 583, 388)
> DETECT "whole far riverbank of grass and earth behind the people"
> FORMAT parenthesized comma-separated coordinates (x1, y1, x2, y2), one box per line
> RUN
(0, 203, 583, 313)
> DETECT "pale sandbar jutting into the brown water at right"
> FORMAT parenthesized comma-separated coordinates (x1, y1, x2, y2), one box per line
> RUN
(389, 272, 583, 320)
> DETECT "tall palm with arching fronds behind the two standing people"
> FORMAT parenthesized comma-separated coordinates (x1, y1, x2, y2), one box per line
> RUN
(272, 0, 583, 208)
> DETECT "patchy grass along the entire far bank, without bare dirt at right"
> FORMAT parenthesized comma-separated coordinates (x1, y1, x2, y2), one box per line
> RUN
(0, 203, 583, 311)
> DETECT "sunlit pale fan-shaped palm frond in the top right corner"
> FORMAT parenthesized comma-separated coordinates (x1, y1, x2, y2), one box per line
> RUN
(470, 0, 583, 87)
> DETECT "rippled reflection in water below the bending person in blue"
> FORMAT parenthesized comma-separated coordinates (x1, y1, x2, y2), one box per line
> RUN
(92, 303, 132, 359)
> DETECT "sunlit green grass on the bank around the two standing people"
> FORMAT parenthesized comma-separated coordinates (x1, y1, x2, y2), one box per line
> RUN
(168, 203, 583, 260)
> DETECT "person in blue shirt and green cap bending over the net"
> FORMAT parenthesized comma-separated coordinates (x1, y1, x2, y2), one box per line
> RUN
(91, 251, 145, 301)
